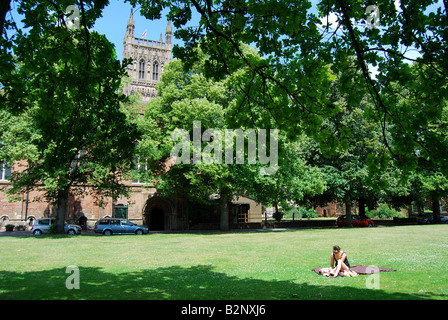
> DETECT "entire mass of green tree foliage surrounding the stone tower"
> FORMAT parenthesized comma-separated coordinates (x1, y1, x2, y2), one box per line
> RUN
(0, 0, 448, 230)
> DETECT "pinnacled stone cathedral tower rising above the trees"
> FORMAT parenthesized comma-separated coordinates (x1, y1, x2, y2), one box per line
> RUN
(123, 10, 172, 103)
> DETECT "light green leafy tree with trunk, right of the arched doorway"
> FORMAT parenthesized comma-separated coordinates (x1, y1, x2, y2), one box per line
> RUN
(139, 47, 310, 230)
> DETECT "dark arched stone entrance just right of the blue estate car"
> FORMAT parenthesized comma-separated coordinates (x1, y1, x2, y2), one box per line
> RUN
(143, 196, 174, 231)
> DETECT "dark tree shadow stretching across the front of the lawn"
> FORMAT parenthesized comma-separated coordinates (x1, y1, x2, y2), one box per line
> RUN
(0, 265, 447, 300)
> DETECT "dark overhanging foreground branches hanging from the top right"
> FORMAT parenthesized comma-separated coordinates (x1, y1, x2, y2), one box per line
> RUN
(129, 0, 448, 176)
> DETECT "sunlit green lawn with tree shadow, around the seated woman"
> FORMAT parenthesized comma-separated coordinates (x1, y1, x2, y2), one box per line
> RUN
(0, 225, 448, 300)
